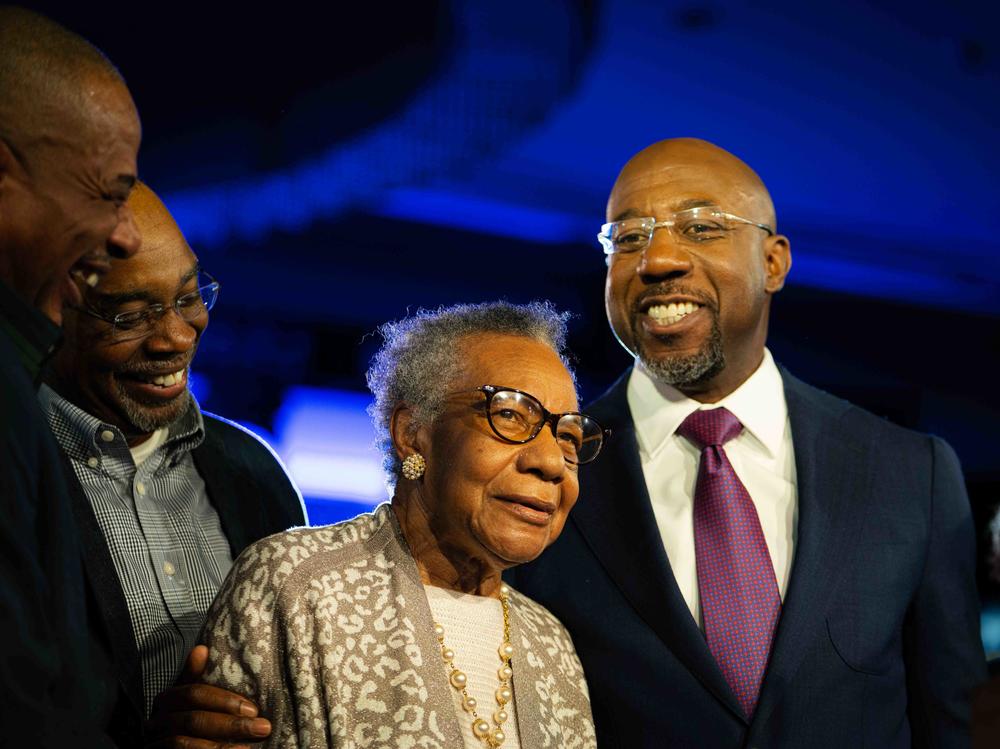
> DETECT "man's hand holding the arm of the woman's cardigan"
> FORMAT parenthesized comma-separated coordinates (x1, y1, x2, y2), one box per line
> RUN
(146, 645, 271, 749)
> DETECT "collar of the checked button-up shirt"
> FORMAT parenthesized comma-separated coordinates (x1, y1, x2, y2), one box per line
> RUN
(38, 384, 205, 460)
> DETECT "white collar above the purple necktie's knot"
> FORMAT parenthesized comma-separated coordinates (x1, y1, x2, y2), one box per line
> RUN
(627, 348, 788, 457)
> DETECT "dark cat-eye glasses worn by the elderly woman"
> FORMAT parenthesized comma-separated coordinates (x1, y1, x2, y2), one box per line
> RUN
(477, 385, 611, 465)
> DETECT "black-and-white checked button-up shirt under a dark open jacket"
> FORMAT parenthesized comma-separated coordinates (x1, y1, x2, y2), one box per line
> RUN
(39, 385, 233, 716)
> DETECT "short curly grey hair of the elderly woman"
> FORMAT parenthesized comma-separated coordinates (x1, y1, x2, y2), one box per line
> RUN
(367, 301, 573, 490)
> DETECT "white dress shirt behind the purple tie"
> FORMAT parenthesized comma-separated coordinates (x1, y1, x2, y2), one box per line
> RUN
(627, 349, 798, 626)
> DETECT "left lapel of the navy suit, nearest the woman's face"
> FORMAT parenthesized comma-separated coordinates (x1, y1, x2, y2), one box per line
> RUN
(570, 372, 743, 718)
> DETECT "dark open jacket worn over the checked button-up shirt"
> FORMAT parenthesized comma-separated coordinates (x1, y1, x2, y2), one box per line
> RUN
(66, 413, 305, 747)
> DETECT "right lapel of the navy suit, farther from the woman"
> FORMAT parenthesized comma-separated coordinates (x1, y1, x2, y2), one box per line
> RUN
(750, 369, 872, 741)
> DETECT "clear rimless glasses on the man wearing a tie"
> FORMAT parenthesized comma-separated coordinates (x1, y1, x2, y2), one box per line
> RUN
(597, 206, 774, 255)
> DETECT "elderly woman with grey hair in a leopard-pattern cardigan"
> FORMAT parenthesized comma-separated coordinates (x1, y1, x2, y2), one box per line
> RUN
(205, 302, 604, 749)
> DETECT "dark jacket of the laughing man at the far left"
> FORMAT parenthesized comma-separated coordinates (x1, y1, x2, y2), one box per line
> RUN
(0, 284, 113, 749)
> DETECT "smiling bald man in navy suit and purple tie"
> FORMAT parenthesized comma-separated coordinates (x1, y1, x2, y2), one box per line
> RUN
(512, 139, 985, 749)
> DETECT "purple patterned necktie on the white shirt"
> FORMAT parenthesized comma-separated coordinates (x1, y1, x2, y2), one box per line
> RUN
(677, 408, 781, 719)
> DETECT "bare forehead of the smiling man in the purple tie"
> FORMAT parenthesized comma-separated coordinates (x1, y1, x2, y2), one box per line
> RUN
(607, 152, 773, 222)
